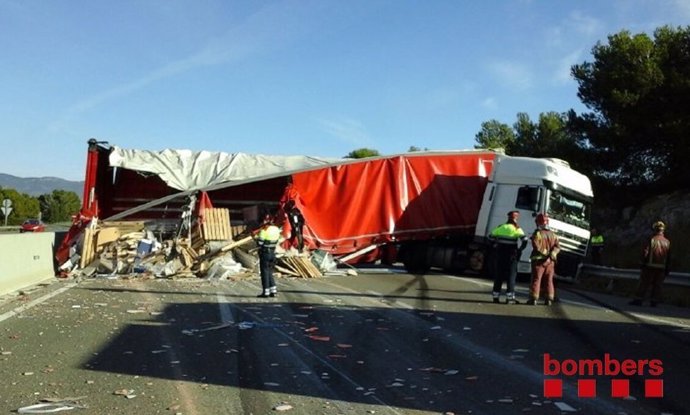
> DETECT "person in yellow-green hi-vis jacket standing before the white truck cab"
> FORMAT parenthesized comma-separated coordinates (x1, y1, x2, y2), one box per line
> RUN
(489, 210, 527, 304)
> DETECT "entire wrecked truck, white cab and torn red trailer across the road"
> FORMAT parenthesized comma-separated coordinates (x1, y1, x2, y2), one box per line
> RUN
(58, 140, 591, 278)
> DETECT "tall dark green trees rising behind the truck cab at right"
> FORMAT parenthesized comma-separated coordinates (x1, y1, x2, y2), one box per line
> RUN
(475, 26, 690, 207)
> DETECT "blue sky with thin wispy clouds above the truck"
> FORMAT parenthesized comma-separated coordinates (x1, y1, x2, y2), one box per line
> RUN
(0, 0, 690, 180)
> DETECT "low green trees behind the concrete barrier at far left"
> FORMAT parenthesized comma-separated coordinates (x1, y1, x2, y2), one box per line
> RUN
(0, 187, 81, 225)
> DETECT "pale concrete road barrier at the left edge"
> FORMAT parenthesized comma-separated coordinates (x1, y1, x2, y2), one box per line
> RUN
(0, 232, 58, 295)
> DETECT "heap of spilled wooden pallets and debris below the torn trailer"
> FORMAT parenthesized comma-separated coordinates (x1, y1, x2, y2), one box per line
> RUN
(60, 192, 326, 280)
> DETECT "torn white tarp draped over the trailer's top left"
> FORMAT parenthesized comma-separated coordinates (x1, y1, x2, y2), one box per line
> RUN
(110, 147, 343, 191)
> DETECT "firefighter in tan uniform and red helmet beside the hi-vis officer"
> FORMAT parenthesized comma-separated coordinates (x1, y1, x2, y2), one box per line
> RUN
(527, 213, 561, 305)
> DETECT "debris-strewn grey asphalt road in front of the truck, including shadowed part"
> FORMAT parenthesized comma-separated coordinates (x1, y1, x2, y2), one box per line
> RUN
(0, 270, 690, 415)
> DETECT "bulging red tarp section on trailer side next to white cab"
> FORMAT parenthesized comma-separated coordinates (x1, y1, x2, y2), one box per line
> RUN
(284, 152, 496, 254)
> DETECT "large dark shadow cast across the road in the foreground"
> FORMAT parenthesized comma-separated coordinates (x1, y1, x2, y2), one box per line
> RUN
(83, 293, 690, 413)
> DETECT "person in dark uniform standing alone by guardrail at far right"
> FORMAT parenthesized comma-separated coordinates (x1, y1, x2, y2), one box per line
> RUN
(630, 221, 671, 307)
